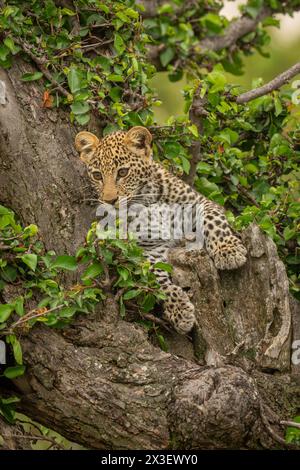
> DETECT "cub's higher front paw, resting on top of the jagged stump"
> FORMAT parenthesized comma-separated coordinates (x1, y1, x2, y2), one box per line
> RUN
(213, 235, 247, 270)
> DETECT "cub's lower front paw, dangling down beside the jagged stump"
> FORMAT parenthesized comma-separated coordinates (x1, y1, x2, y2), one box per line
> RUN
(164, 286, 196, 334)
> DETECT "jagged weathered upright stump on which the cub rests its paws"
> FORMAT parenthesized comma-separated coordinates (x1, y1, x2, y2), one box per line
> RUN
(171, 225, 291, 371)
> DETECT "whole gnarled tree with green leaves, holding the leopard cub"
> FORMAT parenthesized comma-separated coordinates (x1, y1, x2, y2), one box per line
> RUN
(0, 0, 300, 449)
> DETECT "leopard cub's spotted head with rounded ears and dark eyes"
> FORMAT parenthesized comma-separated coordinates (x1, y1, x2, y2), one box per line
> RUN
(75, 126, 152, 205)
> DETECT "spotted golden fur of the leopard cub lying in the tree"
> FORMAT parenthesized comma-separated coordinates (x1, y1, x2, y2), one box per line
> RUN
(75, 126, 246, 333)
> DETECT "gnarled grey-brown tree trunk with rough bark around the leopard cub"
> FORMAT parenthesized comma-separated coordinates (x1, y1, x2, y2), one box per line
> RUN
(0, 62, 300, 449)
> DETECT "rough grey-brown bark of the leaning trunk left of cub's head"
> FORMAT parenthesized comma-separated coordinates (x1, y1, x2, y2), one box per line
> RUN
(0, 62, 95, 251)
